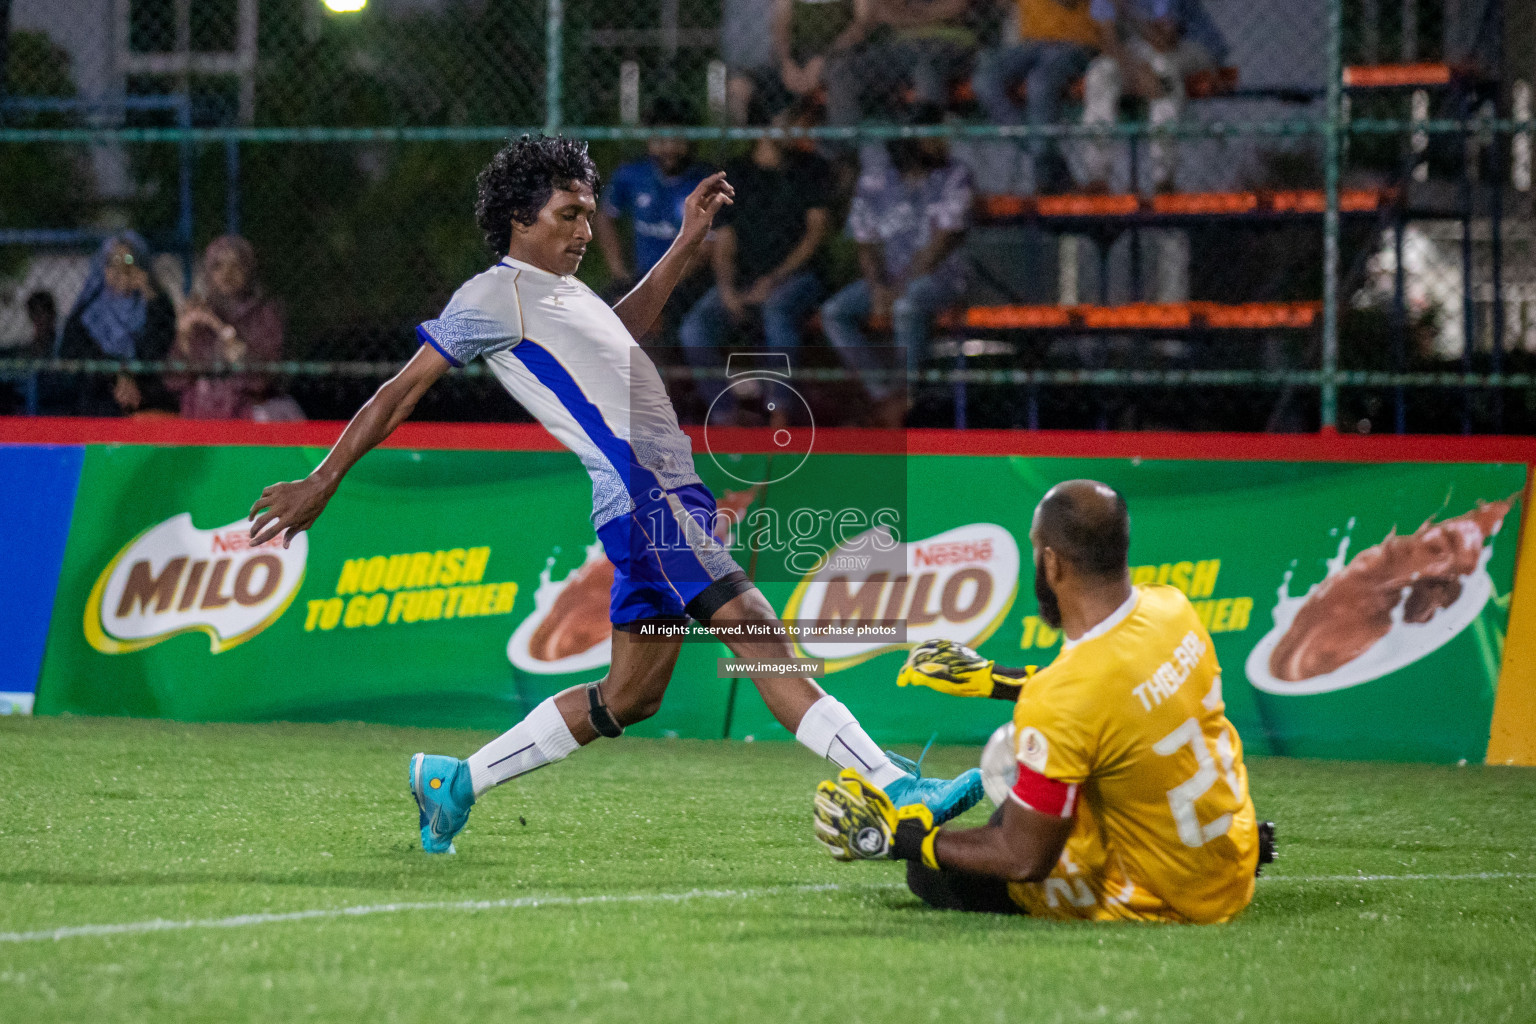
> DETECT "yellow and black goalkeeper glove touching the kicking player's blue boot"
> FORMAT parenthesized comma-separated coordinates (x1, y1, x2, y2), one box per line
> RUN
(814, 768, 938, 869)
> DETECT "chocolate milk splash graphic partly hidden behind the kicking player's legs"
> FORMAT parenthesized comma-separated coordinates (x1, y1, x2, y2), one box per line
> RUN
(507, 487, 760, 676)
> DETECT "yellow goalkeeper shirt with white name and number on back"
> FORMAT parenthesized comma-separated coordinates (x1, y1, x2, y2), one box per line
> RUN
(1009, 583, 1258, 923)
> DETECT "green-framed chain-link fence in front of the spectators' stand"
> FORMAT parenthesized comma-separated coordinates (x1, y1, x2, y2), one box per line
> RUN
(0, 0, 1536, 433)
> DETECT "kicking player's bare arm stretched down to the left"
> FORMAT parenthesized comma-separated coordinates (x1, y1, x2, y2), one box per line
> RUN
(249, 345, 449, 548)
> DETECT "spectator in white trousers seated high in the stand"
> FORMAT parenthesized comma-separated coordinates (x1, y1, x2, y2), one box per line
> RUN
(1083, 0, 1227, 192)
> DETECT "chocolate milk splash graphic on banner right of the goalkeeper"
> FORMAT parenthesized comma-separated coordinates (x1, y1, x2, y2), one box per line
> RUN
(1247, 499, 1513, 695)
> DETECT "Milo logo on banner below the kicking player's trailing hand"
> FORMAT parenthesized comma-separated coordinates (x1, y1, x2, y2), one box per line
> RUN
(84, 513, 309, 654)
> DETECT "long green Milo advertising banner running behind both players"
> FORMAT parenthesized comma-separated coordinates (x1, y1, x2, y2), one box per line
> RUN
(35, 445, 1525, 761)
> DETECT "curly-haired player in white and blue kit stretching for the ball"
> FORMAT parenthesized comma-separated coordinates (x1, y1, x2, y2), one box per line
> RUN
(250, 135, 983, 854)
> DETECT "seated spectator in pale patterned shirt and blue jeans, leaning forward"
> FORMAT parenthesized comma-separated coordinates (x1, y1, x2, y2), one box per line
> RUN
(822, 109, 975, 427)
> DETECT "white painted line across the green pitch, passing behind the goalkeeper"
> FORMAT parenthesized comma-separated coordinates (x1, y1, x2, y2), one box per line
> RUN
(0, 872, 1536, 943)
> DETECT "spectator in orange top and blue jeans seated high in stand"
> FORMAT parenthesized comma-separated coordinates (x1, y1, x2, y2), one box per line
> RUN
(972, 0, 1107, 195)
